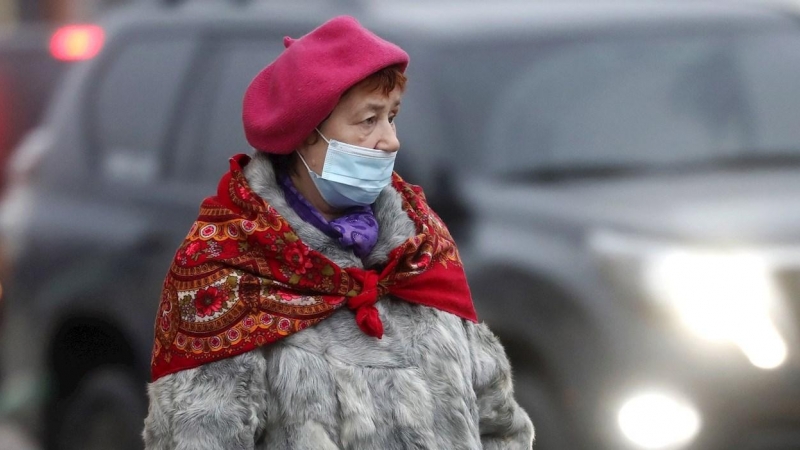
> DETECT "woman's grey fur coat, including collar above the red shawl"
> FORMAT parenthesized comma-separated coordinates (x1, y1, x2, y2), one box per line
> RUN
(143, 154, 533, 450)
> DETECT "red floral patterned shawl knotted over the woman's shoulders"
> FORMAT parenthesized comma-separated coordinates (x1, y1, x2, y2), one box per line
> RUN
(151, 155, 477, 380)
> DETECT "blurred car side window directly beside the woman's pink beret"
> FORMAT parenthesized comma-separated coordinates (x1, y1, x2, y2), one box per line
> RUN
(177, 38, 283, 180)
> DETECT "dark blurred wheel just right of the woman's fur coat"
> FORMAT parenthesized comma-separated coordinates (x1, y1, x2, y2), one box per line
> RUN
(514, 373, 581, 450)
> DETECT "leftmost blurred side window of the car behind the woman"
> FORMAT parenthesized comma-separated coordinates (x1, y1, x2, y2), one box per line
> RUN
(93, 36, 194, 183)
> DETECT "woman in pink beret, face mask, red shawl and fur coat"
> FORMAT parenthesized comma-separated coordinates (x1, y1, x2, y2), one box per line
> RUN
(144, 17, 533, 450)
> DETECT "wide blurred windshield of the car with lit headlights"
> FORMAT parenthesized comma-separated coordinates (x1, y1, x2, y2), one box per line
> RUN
(439, 25, 800, 178)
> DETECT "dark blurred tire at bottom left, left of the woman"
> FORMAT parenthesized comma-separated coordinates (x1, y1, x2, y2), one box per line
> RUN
(50, 368, 147, 450)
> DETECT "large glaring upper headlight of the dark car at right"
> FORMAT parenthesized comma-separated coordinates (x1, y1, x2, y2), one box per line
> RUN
(591, 233, 788, 369)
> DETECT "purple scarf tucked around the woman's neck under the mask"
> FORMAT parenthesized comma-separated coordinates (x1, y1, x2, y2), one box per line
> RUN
(280, 175, 378, 258)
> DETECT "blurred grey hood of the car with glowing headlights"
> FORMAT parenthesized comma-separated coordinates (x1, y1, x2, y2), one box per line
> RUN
(458, 167, 800, 243)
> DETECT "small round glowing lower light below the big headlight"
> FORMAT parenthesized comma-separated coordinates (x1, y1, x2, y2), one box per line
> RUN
(617, 392, 700, 449)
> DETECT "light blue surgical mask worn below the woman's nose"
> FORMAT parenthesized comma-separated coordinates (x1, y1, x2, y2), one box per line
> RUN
(298, 130, 397, 208)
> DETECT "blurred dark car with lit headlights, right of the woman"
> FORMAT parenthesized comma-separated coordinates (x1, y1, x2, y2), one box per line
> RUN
(386, 2, 800, 450)
